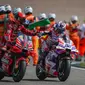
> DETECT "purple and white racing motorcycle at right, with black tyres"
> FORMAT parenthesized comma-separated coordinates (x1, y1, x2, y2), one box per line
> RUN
(36, 38, 78, 81)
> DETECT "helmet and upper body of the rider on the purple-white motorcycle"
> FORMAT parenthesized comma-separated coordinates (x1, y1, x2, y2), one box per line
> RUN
(44, 21, 66, 49)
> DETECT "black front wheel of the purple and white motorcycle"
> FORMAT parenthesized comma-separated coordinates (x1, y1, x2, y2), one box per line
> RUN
(58, 59, 71, 81)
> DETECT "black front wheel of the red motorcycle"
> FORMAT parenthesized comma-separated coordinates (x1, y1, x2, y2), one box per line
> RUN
(13, 60, 26, 82)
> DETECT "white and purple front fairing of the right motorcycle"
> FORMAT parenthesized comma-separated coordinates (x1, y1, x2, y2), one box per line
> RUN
(56, 38, 78, 54)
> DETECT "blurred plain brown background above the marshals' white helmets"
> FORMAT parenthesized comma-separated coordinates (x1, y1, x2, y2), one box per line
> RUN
(0, 0, 85, 23)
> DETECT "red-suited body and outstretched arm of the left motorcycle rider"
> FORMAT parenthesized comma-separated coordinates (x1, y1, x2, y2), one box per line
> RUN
(4, 13, 36, 58)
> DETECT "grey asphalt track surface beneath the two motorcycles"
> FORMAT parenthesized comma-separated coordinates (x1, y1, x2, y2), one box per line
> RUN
(0, 65, 85, 85)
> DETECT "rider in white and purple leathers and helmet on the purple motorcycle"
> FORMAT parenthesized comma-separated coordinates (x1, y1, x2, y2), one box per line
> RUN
(39, 21, 66, 66)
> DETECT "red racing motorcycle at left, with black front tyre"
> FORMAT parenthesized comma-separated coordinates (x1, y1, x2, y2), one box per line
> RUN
(0, 32, 28, 82)
